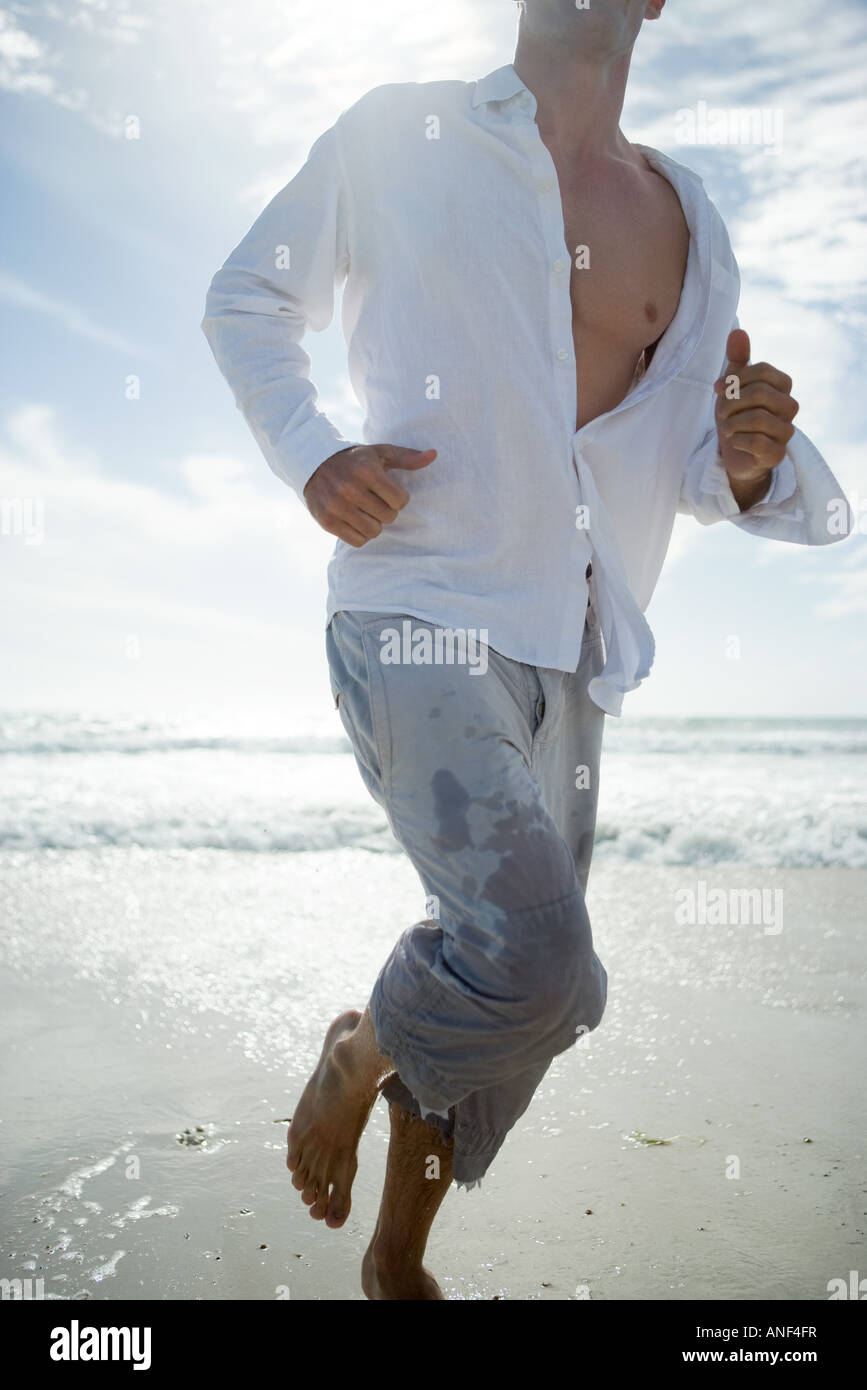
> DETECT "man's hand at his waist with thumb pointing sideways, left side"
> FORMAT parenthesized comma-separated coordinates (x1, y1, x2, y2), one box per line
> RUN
(304, 443, 436, 548)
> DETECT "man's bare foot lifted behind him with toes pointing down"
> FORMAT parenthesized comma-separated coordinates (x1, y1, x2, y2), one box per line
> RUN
(286, 1009, 388, 1230)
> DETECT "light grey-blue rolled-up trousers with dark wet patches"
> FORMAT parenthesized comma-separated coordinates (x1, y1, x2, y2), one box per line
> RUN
(327, 609, 607, 1187)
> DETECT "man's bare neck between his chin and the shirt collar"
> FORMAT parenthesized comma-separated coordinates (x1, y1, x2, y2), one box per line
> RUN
(513, 35, 631, 158)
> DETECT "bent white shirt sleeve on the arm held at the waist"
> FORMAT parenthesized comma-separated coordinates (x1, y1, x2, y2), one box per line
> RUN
(201, 125, 356, 498)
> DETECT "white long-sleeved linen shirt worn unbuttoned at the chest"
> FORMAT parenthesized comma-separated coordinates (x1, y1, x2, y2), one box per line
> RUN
(201, 64, 843, 714)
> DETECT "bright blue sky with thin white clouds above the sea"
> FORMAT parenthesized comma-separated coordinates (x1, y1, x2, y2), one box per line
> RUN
(0, 0, 867, 726)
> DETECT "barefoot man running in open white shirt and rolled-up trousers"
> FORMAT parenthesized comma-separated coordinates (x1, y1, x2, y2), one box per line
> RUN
(203, 0, 841, 1300)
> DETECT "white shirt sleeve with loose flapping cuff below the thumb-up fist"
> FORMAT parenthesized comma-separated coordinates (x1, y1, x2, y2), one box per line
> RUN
(678, 318, 853, 545)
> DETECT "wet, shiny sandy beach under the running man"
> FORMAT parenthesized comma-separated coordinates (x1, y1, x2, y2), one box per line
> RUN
(0, 848, 867, 1300)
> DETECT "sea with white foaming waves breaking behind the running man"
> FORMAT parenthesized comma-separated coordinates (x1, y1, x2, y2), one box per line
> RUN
(0, 710, 867, 869)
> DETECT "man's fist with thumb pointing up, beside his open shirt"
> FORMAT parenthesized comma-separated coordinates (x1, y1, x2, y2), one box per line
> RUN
(714, 328, 800, 510)
